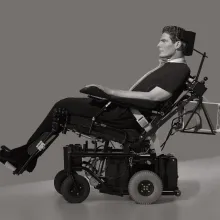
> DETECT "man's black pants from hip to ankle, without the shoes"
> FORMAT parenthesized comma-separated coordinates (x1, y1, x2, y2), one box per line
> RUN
(27, 97, 139, 145)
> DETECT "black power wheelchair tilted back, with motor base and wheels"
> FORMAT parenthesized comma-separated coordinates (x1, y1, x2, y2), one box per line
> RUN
(2, 31, 215, 204)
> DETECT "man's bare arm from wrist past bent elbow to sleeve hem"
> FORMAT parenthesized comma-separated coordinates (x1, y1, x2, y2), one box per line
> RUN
(110, 86, 172, 101)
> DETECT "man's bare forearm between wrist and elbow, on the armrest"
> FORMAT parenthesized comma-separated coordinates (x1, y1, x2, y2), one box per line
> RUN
(111, 89, 154, 101)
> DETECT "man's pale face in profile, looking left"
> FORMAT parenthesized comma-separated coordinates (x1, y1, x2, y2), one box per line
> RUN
(157, 33, 176, 59)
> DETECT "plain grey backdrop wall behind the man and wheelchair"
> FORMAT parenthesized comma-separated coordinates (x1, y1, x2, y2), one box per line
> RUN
(0, 0, 217, 185)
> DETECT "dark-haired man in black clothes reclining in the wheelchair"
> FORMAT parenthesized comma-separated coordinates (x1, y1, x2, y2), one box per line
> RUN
(0, 26, 190, 172)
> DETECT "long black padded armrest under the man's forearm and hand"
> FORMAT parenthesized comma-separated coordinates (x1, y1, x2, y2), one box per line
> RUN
(80, 86, 161, 110)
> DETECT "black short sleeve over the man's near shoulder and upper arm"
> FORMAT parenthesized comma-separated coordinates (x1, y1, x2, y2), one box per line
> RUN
(156, 65, 190, 94)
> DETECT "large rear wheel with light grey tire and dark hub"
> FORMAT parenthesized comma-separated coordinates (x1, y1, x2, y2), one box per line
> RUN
(128, 170, 163, 205)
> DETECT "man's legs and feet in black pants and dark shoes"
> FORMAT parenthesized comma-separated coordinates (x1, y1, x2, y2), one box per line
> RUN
(0, 98, 140, 172)
